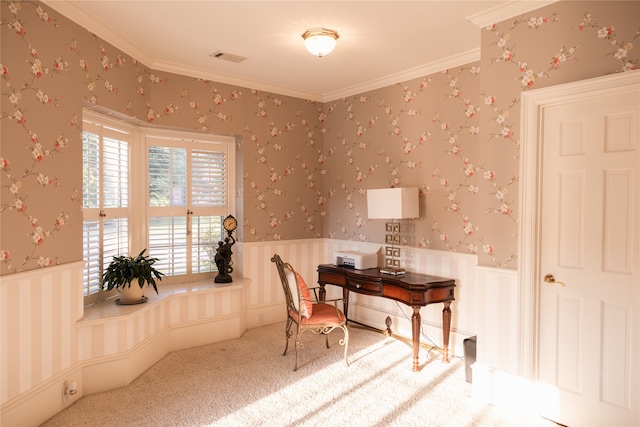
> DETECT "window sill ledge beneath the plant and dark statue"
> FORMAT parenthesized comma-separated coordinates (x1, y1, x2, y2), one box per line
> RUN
(80, 278, 249, 323)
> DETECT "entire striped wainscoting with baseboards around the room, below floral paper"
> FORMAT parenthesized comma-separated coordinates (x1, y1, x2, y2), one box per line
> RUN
(0, 239, 510, 425)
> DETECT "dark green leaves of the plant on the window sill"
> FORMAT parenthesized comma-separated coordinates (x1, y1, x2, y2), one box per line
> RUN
(102, 248, 164, 294)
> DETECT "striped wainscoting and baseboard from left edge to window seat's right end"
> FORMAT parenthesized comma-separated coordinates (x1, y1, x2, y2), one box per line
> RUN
(0, 268, 249, 426)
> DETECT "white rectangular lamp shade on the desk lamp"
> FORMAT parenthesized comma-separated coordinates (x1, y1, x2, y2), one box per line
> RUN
(367, 188, 420, 219)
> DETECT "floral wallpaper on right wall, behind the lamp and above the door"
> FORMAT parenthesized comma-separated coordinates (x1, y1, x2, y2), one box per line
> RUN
(324, 2, 640, 268)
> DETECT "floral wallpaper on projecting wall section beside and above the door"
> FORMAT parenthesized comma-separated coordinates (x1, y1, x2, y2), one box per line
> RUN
(477, 1, 640, 268)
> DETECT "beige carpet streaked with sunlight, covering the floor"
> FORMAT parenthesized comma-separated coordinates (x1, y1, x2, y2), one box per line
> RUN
(43, 324, 555, 427)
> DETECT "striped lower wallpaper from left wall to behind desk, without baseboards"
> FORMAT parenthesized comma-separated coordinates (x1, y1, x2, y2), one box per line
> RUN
(0, 239, 504, 426)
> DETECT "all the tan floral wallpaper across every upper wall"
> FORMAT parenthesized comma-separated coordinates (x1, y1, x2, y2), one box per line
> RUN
(0, 1, 640, 274)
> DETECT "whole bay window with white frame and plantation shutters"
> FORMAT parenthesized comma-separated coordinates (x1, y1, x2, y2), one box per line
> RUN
(82, 111, 235, 304)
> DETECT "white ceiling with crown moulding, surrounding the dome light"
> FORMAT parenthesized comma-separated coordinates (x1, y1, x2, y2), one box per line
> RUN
(43, 0, 549, 101)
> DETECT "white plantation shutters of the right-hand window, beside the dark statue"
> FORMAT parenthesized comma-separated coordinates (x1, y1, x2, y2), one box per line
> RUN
(147, 135, 229, 276)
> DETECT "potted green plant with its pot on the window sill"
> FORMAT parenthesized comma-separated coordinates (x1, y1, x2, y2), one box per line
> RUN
(102, 248, 164, 305)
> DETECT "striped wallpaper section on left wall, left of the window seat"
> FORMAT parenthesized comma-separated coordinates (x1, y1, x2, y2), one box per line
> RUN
(0, 262, 83, 403)
